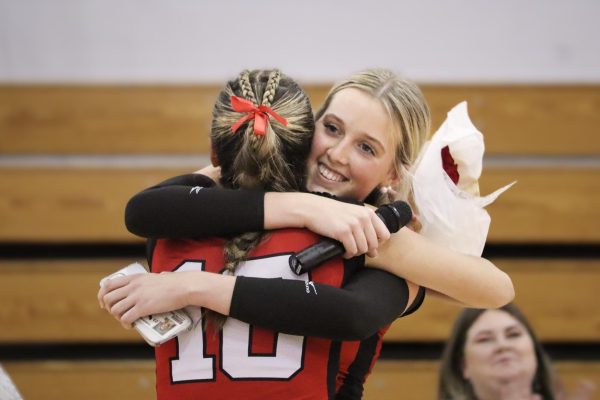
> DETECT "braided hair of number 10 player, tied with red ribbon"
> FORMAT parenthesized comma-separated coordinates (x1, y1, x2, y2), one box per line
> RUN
(207, 70, 315, 327)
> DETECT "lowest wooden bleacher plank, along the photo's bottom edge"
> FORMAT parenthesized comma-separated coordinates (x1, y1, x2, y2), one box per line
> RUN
(4, 360, 600, 400)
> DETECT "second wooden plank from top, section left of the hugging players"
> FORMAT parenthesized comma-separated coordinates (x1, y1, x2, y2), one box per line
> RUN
(0, 168, 190, 243)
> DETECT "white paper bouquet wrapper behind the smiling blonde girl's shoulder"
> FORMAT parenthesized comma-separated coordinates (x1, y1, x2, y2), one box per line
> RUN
(412, 102, 515, 256)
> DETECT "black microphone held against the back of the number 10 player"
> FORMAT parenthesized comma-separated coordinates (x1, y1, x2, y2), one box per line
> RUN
(290, 200, 412, 275)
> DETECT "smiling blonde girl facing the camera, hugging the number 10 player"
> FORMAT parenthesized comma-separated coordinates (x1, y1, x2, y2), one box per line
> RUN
(99, 70, 514, 398)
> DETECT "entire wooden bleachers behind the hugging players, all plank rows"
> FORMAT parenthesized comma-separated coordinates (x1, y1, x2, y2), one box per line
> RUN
(0, 85, 600, 399)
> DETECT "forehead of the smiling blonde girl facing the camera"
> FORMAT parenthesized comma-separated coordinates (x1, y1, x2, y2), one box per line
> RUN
(325, 88, 392, 143)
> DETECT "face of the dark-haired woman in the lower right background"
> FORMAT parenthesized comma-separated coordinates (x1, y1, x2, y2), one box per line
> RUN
(463, 310, 537, 387)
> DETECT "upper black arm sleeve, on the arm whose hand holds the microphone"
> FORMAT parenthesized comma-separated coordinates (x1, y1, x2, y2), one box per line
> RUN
(125, 174, 264, 239)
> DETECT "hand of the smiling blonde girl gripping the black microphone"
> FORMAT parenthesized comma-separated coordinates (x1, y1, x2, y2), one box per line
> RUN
(296, 194, 390, 258)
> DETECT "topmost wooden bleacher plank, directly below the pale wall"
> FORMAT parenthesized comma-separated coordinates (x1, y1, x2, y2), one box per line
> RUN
(0, 84, 600, 156)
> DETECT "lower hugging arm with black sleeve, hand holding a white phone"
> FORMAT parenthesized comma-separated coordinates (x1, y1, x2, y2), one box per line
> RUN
(98, 269, 422, 340)
